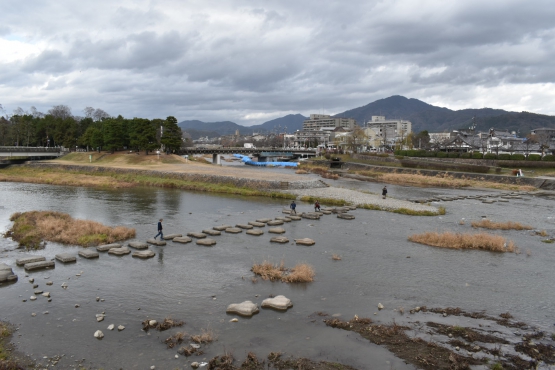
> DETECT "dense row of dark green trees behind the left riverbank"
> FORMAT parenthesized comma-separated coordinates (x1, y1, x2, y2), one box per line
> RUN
(0, 104, 184, 153)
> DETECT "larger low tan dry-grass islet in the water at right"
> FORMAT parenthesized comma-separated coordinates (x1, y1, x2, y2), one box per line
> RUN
(409, 232, 516, 252)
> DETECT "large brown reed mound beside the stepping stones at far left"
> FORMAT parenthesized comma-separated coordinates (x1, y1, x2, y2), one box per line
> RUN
(7, 211, 135, 249)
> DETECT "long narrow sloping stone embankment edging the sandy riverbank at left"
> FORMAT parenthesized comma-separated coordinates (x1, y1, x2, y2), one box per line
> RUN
(23, 162, 326, 190)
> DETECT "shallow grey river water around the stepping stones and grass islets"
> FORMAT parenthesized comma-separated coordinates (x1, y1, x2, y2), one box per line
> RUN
(0, 176, 555, 369)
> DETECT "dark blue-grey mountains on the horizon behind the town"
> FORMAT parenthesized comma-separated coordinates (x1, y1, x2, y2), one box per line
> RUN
(179, 95, 555, 139)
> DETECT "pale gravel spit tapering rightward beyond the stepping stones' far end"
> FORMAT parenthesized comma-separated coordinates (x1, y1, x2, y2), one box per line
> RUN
(287, 187, 437, 212)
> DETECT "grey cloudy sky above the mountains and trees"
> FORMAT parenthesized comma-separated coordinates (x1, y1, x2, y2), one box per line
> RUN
(0, 0, 555, 125)
